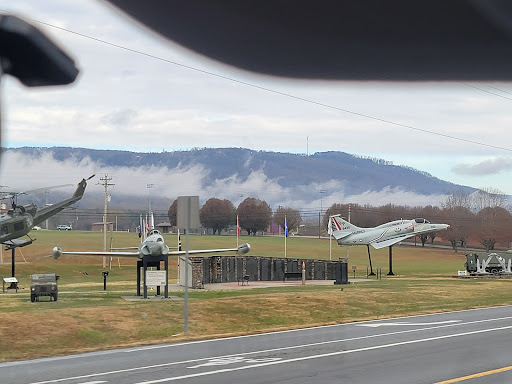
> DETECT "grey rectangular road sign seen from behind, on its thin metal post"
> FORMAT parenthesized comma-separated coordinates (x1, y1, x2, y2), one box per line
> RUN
(176, 196, 201, 333)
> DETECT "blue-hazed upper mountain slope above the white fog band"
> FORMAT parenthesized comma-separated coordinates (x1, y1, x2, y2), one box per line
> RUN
(6, 147, 473, 195)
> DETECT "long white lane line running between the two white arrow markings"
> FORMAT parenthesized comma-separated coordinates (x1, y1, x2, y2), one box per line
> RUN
(23, 316, 512, 384)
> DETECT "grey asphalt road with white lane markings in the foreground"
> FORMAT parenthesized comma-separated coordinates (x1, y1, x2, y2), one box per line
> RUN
(0, 306, 512, 384)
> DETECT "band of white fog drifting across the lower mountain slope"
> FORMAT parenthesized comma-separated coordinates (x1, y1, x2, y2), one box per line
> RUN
(0, 151, 444, 215)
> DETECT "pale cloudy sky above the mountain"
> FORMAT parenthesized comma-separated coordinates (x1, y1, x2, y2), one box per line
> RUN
(0, 0, 512, 204)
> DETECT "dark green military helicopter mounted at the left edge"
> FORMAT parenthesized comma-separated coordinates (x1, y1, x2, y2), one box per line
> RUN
(0, 175, 95, 247)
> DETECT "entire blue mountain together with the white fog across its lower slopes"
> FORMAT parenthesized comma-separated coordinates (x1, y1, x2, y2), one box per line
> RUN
(0, 147, 474, 211)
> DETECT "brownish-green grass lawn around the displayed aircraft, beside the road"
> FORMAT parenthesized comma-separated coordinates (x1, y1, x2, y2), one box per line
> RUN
(0, 231, 506, 361)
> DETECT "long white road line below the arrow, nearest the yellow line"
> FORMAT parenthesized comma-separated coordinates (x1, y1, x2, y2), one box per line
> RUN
(133, 325, 512, 384)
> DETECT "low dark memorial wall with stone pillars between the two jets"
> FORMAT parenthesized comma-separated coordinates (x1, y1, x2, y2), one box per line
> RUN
(179, 256, 340, 288)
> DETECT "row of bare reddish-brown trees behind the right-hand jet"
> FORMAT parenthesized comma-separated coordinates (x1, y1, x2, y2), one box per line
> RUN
(168, 188, 512, 251)
